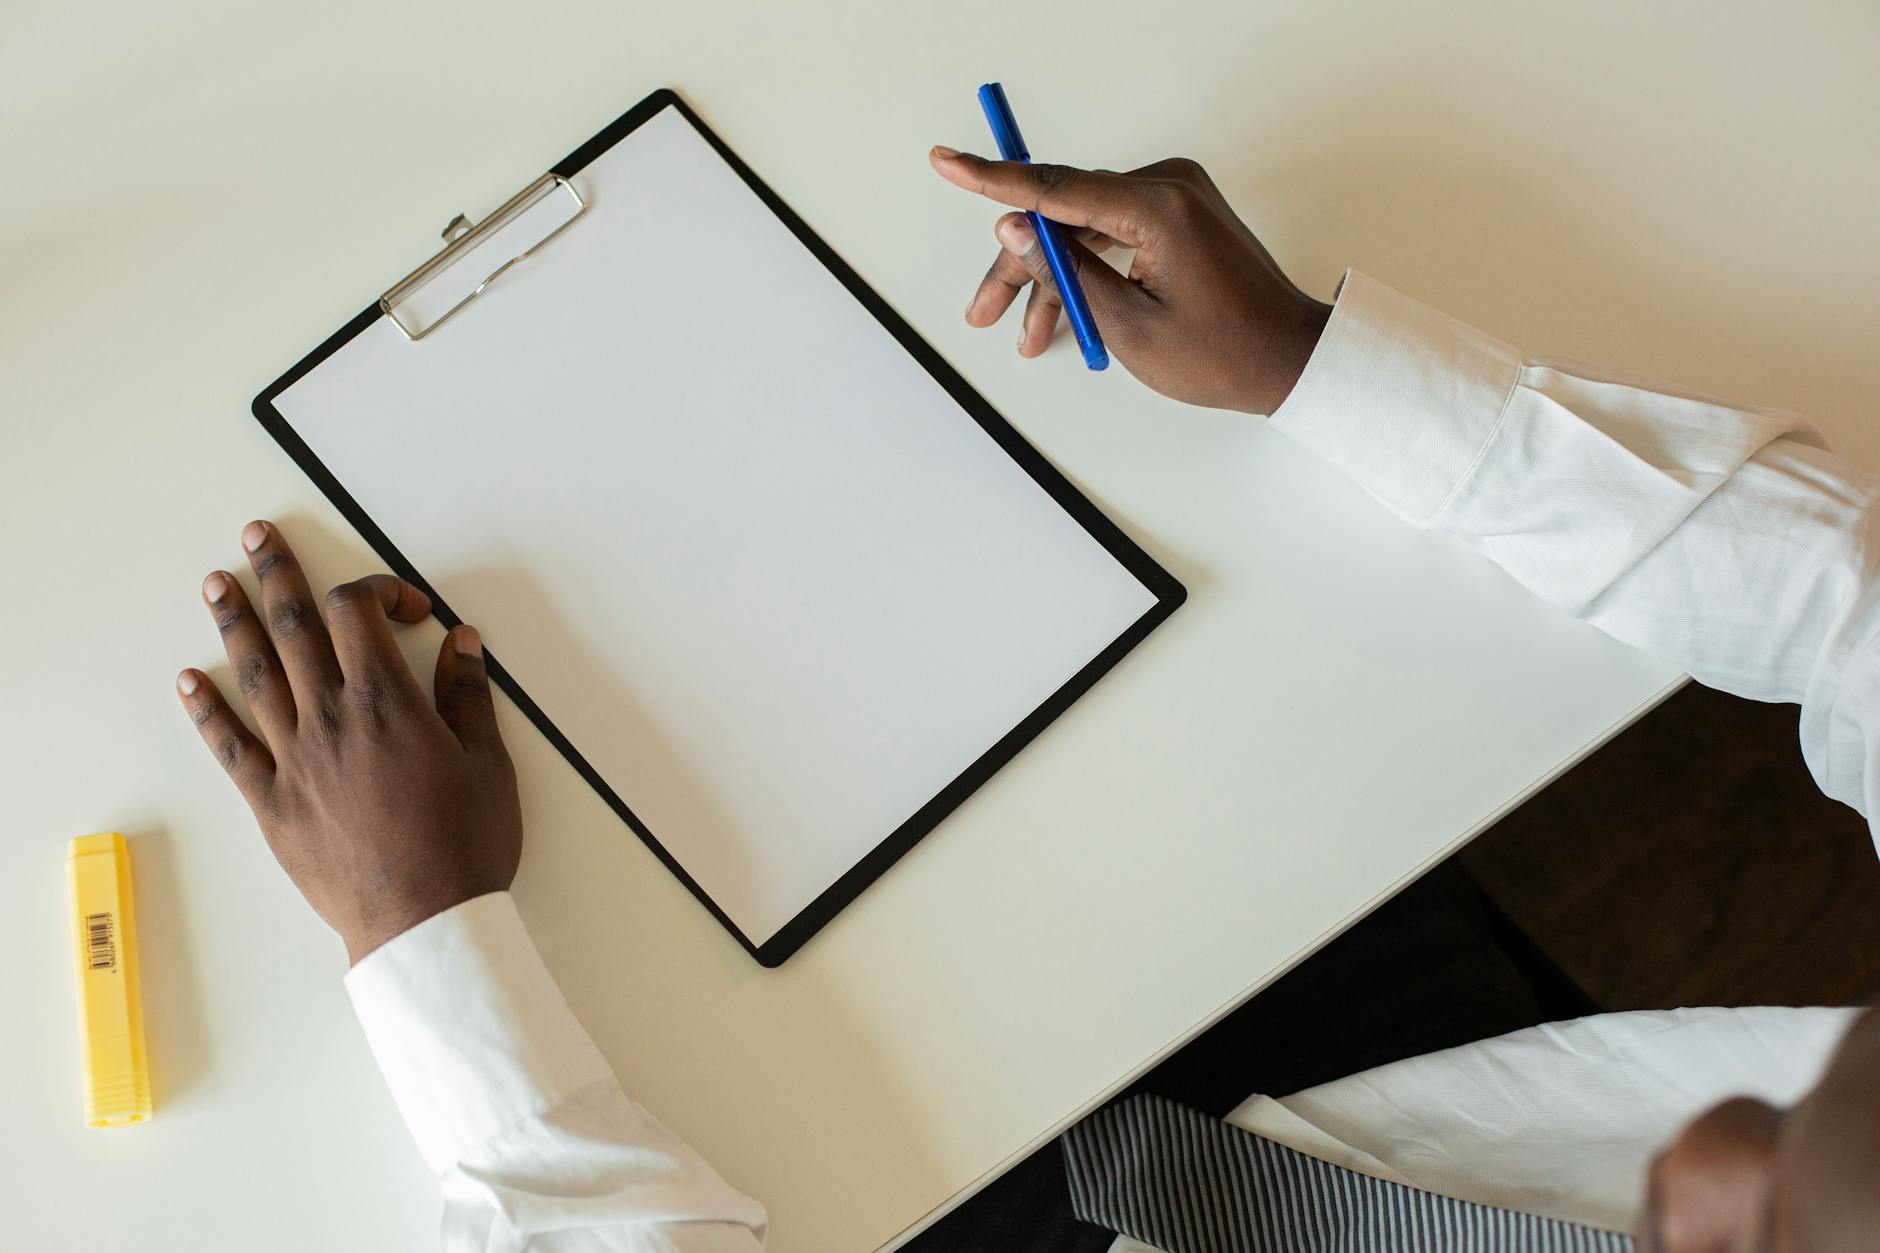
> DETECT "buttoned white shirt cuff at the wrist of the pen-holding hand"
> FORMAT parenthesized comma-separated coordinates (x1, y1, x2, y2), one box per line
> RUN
(1271, 269, 1521, 525)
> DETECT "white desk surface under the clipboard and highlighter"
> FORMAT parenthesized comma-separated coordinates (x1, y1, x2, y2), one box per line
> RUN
(0, 0, 1880, 1253)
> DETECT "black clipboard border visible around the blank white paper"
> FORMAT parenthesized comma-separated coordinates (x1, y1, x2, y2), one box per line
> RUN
(254, 88, 1188, 967)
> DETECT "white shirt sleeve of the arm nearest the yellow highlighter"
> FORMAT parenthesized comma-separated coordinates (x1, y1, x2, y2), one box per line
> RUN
(346, 892, 765, 1253)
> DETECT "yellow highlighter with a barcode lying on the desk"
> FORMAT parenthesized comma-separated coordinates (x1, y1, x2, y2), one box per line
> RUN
(68, 833, 150, 1127)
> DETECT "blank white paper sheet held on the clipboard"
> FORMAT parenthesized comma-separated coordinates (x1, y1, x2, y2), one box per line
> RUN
(274, 107, 1158, 946)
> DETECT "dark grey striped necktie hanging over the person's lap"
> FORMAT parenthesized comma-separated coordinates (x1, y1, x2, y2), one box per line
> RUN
(1064, 1097, 1632, 1253)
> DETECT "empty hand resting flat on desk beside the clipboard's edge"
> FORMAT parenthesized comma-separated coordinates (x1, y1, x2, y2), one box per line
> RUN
(177, 521, 523, 961)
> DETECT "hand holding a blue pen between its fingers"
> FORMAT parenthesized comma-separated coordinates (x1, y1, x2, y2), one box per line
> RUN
(929, 147, 1331, 414)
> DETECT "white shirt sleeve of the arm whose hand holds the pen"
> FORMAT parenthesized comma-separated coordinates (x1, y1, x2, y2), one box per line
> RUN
(1273, 271, 1880, 839)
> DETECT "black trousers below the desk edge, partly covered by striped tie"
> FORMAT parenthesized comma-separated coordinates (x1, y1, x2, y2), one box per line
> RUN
(906, 864, 1598, 1253)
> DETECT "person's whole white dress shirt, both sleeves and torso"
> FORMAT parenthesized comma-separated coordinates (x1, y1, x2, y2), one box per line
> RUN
(346, 273, 1880, 1253)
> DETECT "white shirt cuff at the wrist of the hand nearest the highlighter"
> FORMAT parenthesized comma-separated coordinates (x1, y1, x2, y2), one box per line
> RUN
(346, 892, 613, 1174)
